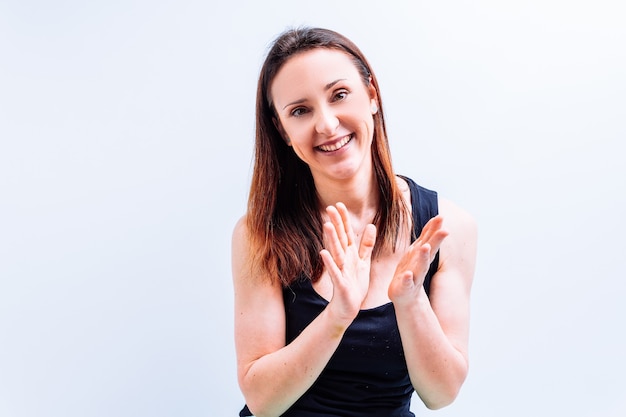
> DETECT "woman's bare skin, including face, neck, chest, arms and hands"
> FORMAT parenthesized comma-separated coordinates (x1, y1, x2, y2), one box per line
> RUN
(232, 49, 476, 417)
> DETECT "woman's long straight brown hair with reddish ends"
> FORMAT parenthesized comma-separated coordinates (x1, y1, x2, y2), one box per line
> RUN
(247, 27, 410, 285)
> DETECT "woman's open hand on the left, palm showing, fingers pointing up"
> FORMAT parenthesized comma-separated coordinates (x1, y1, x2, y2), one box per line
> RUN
(320, 203, 376, 327)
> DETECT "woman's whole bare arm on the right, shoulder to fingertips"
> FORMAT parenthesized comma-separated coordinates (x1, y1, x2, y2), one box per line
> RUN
(389, 200, 477, 409)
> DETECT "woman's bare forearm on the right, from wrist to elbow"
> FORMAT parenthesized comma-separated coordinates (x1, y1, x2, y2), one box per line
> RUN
(396, 292, 468, 409)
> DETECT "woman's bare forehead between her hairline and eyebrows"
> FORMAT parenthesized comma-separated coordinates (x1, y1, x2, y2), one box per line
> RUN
(270, 48, 361, 101)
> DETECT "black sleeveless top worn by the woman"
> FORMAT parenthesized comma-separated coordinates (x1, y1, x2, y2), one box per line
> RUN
(239, 177, 439, 417)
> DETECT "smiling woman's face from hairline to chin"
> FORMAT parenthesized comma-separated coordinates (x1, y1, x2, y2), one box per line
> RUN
(270, 48, 377, 179)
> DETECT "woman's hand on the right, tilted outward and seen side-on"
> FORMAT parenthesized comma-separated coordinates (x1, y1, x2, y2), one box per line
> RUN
(388, 216, 448, 306)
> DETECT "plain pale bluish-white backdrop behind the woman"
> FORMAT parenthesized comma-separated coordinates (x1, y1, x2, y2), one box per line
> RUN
(0, 0, 626, 417)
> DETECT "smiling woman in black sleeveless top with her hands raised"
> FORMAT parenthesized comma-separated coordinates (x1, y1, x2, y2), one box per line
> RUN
(232, 28, 476, 417)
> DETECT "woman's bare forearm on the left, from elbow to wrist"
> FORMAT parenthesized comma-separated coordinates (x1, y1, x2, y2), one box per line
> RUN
(240, 308, 348, 417)
